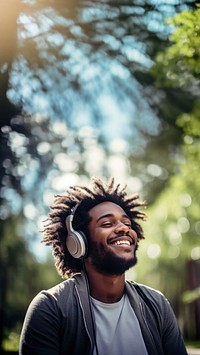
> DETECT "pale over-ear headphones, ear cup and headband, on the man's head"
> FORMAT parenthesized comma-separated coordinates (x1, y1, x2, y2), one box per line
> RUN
(65, 203, 87, 259)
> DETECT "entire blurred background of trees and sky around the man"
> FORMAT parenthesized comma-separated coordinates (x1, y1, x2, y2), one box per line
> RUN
(0, 0, 200, 351)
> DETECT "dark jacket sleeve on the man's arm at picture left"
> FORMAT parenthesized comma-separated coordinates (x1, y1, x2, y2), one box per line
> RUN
(19, 293, 60, 355)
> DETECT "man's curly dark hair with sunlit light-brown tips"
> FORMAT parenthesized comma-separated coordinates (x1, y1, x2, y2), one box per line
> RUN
(42, 177, 146, 278)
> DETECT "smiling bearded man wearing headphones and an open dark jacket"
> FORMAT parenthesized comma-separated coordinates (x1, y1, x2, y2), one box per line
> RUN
(19, 178, 187, 355)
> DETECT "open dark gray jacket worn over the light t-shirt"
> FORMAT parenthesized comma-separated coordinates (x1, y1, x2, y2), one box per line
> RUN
(19, 274, 187, 355)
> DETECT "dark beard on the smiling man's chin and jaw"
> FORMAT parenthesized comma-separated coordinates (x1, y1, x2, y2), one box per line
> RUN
(89, 242, 138, 275)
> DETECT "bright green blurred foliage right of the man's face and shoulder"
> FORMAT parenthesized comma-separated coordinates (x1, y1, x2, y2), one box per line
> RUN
(129, 124, 200, 337)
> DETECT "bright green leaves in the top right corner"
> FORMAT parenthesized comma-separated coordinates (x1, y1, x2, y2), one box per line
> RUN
(152, 5, 200, 88)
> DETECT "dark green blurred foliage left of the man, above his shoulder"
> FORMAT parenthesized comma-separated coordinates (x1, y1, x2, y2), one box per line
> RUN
(0, 215, 60, 350)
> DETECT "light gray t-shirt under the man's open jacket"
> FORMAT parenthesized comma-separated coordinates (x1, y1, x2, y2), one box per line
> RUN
(91, 294, 148, 355)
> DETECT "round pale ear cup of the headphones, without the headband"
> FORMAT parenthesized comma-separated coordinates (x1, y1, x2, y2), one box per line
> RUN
(66, 230, 87, 259)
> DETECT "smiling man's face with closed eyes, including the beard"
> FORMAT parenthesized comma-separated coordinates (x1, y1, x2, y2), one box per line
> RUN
(87, 201, 138, 275)
